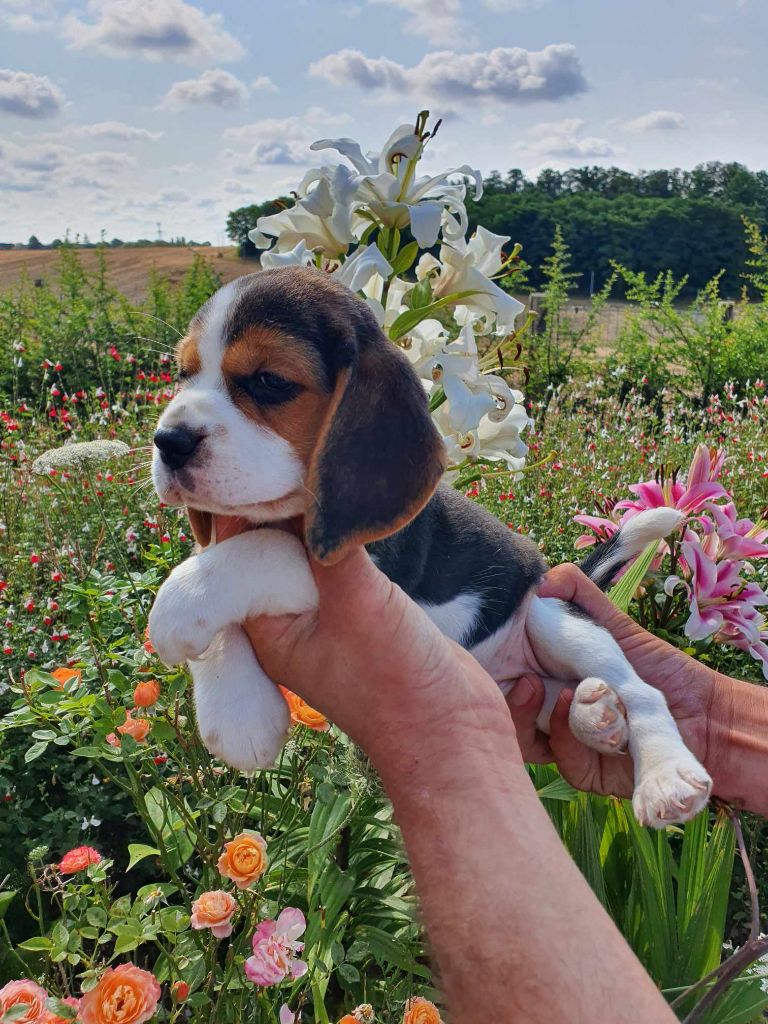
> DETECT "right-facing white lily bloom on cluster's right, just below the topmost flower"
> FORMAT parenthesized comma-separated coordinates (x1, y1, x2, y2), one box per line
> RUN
(416, 225, 525, 334)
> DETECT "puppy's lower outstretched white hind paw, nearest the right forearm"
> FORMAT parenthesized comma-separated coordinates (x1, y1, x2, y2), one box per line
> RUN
(632, 751, 712, 828)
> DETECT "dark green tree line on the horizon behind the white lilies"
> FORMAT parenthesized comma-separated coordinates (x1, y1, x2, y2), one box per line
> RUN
(226, 162, 768, 296)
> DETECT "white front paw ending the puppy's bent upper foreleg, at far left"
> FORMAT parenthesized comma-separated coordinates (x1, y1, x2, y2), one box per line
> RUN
(150, 558, 216, 668)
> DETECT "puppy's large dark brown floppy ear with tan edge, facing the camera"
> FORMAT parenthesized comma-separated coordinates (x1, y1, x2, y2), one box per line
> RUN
(305, 323, 445, 564)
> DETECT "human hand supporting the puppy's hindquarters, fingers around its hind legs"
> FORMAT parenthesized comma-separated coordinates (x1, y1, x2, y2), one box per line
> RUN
(507, 565, 730, 797)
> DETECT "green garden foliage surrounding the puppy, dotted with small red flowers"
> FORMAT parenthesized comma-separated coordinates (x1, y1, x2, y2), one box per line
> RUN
(0, 237, 768, 1024)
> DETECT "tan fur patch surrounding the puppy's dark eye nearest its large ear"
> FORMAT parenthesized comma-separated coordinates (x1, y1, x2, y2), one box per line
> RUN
(221, 327, 332, 465)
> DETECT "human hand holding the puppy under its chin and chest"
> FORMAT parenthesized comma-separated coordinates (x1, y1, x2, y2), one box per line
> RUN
(237, 535, 511, 767)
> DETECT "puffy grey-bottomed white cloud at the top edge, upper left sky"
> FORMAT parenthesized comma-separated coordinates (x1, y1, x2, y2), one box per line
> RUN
(63, 0, 245, 63)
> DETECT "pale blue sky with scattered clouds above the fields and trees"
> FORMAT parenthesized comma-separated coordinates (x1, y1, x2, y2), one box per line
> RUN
(0, 0, 768, 244)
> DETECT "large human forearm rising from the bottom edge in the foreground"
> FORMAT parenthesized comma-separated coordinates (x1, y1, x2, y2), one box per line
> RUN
(371, 684, 674, 1024)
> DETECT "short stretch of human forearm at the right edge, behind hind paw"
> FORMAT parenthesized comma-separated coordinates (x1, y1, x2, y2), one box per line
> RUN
(707, 676, 768, 816)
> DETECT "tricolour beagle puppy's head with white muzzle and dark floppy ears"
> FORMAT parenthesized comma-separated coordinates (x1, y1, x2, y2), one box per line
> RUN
(153, 267, 443, 562)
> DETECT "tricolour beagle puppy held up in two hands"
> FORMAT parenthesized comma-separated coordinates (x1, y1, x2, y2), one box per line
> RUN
(150, 267, 712, 827)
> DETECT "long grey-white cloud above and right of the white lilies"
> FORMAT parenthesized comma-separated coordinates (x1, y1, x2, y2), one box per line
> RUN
(309, 43, 588, 103)
